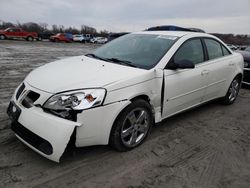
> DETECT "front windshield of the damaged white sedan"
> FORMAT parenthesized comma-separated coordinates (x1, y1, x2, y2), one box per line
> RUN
(89, 34, 178, 69)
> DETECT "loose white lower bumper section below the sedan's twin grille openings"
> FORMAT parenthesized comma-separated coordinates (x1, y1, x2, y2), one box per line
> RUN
(9, 100, 81, 162)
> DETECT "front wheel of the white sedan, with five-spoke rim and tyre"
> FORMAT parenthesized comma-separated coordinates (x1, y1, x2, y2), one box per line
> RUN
(110, 99, 153, 151)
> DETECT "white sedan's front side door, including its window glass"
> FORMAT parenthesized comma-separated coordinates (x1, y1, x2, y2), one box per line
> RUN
(162, 38, 207, 118)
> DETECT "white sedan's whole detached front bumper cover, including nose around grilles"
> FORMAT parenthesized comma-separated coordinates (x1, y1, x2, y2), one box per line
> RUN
(7, 83, 81, 162)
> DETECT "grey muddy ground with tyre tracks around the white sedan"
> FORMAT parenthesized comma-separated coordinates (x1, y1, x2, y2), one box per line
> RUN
(0, 41, 250, 188)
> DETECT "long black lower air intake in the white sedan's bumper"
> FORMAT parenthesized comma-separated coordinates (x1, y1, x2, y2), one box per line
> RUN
(11, 121, 53, 155)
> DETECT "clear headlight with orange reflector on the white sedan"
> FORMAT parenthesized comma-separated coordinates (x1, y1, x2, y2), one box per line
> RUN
(43, 89, 106, 110)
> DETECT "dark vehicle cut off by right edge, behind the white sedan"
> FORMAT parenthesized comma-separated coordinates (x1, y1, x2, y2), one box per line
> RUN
(237, 46, 250, 86)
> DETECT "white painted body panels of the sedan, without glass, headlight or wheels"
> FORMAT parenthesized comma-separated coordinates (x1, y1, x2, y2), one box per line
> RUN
(9, 31, 243, 162)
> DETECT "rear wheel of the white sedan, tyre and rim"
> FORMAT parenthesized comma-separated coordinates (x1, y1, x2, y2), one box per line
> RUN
(222, 76, 241, 105)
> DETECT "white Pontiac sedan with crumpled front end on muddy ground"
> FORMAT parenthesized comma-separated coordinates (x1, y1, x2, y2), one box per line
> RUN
(7, 31, 243, 162)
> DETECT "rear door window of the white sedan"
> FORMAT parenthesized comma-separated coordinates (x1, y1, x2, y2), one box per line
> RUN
(204, 39, 223, 59)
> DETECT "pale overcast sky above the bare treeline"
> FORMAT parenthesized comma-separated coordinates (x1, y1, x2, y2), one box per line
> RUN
(0, 0, 250, 34)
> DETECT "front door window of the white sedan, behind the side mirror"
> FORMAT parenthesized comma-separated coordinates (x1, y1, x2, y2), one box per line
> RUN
(174, 39, 204, 64)
